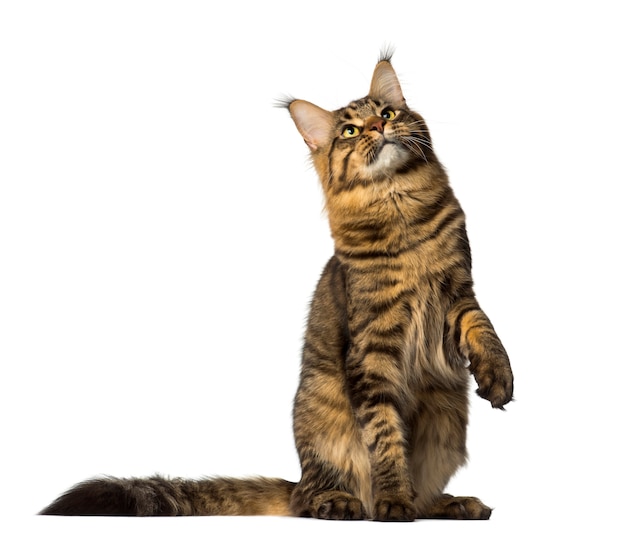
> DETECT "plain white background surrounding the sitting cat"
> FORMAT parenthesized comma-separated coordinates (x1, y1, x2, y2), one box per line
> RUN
(0, 0, 626, 531)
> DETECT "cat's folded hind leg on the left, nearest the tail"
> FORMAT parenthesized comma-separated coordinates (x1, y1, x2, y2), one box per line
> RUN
(290, 259, 372, 520)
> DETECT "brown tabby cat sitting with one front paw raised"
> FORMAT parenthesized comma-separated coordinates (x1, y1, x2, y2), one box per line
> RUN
(41, 52, 513, 521)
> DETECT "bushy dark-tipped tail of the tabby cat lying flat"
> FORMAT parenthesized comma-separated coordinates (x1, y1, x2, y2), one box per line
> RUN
(39, 476, 296, 516)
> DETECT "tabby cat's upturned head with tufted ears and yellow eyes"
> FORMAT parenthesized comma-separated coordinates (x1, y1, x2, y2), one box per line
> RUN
(286, 56, 434, 192)
